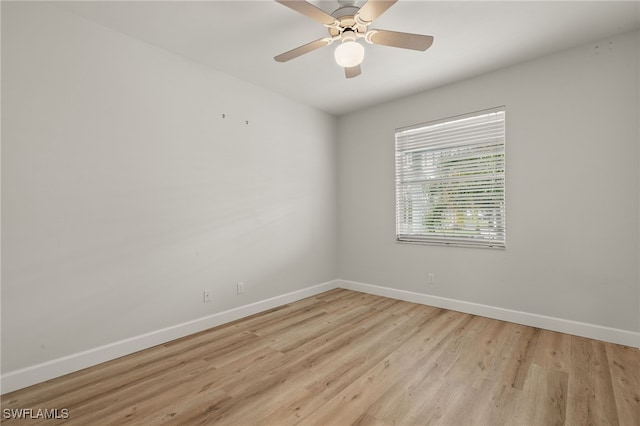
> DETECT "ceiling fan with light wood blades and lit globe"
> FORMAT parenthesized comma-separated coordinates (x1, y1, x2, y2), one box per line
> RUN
(274, 0, 433, 78)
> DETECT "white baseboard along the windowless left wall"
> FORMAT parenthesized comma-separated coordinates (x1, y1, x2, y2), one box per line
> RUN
(0, 281, 337, 394)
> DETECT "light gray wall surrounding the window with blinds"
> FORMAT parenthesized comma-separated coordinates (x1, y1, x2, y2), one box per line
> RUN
(338, 32, 640, 331)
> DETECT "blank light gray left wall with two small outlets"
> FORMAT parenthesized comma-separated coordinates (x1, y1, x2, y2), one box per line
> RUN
(2, 3, 337, 373)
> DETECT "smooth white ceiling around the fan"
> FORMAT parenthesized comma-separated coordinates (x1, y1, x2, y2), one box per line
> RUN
(57, 0, 640, 115)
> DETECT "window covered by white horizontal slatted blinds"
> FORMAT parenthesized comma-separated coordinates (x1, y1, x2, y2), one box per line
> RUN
(396, 107, 505, 248)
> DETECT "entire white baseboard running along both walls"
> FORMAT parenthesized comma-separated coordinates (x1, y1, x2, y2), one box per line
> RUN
(0, 280, 640, 394)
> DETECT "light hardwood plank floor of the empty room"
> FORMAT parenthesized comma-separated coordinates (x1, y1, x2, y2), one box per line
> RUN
(2, 289, 640, 426)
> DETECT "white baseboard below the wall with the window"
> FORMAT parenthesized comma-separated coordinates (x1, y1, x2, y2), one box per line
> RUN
(337, 280, 640, 348)
